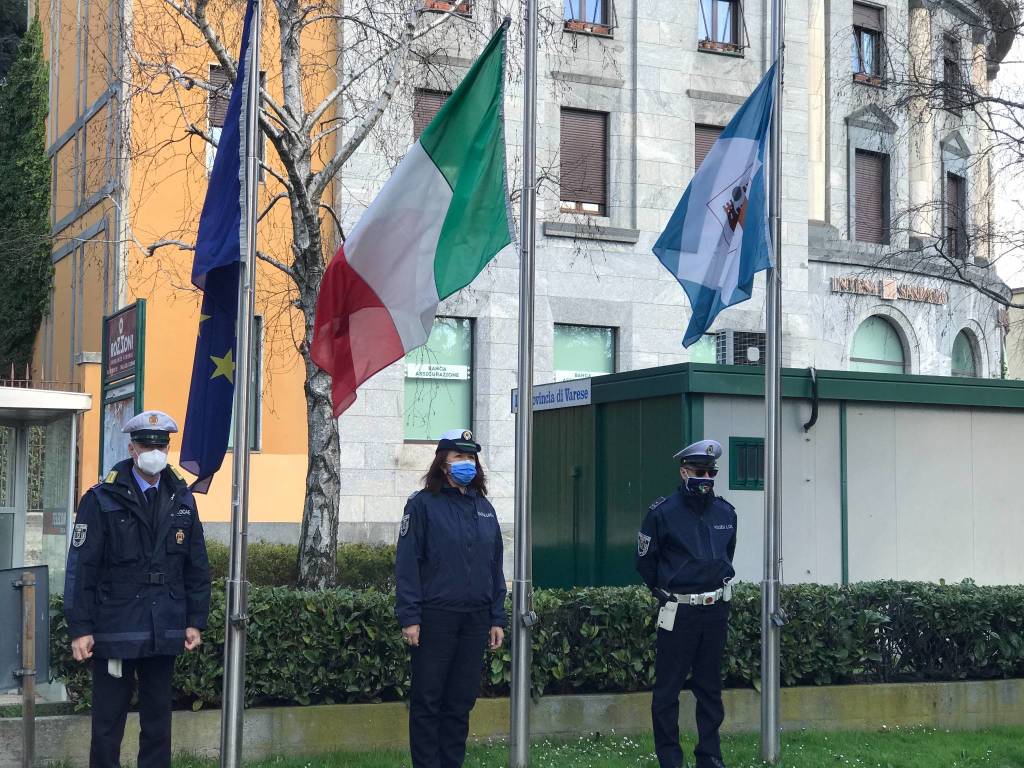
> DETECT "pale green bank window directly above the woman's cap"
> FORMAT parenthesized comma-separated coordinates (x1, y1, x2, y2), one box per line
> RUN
(406, 317, 473, 440)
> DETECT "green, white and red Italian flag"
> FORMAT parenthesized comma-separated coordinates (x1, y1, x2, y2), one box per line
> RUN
(310, 24, 512, 416)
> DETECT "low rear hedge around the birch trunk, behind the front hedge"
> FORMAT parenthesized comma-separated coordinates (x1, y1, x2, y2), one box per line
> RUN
(206, 542, 394, 592)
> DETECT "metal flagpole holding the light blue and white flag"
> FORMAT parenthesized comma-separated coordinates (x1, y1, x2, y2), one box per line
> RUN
(761, 0, 785, 764)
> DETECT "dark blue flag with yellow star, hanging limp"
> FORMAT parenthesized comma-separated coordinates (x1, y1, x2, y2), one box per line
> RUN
(181, 0, 253, 493)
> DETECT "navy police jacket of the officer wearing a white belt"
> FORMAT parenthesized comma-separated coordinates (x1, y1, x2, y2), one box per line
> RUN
(636, 486, 736, 594)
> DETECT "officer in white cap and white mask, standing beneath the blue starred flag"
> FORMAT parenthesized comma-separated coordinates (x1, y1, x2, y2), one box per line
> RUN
(65, 411, 210, 768)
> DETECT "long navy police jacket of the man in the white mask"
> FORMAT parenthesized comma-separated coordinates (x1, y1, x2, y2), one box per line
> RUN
(65, 459, 210, 658)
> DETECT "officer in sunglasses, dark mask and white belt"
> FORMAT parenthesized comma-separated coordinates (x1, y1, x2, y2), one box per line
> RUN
(636, 440, 736, 768)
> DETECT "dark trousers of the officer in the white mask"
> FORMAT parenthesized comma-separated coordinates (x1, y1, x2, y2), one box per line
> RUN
(89, 656, 175, 768)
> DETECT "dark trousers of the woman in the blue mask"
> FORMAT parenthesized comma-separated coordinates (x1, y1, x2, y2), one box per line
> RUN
(409, 608, 490, 768)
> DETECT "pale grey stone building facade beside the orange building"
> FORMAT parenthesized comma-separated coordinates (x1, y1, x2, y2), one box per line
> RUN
(323, 0, 1006, 552)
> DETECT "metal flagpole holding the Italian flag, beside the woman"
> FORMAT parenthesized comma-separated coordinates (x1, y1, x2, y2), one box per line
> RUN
(509, 0, 537, 768)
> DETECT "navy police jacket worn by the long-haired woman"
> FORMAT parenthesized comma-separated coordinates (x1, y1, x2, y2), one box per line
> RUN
(394, 487, 506, 627)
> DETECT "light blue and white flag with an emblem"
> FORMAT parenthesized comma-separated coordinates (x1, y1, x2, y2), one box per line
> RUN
(654, 65, 776, 347)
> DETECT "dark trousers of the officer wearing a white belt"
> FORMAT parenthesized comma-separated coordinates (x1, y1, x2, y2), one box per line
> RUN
(651, 603, 729, 768)
